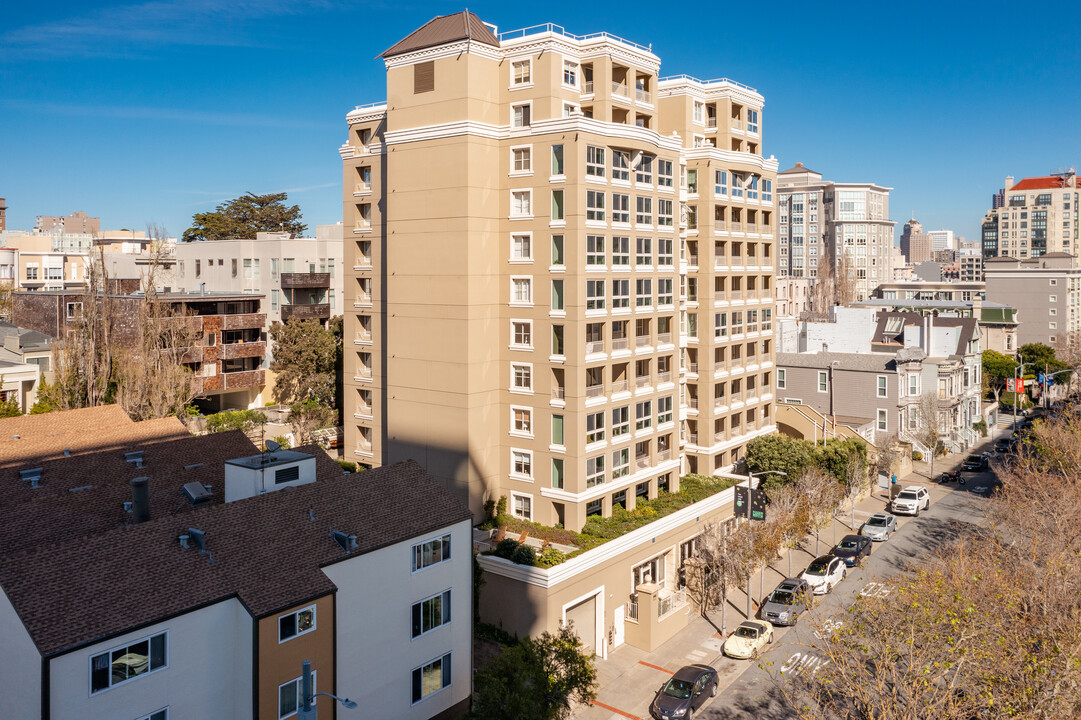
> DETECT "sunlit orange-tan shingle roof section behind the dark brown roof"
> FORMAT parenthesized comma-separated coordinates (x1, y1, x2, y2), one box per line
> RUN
(0, 411, 191, 470)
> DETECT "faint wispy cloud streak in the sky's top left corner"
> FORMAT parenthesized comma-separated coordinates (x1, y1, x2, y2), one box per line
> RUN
(0, 0, 336, 57)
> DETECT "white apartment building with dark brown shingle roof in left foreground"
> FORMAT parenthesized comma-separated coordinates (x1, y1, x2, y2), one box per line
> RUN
(0, 408, 472, 720)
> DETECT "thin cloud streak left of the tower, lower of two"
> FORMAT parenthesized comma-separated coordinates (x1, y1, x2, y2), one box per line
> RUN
(0, 99, 338, 130)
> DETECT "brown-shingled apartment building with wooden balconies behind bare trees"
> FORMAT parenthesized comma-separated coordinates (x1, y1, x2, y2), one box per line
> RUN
(12, 291, 269, 412)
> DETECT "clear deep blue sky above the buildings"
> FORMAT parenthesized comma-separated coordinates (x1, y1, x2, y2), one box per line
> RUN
(0, 0, 1081, 239)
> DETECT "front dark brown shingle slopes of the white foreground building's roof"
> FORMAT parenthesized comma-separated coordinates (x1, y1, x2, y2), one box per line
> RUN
(0, 449, 471, 656)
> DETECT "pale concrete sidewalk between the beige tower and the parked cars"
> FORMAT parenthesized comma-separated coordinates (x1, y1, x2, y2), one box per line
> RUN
(573, 429, 1007, 720)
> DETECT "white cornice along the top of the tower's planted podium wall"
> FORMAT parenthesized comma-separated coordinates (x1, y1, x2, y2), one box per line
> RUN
(477, 476, 736, 589)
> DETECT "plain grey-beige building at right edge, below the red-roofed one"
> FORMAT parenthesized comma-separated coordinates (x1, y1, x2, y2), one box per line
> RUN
(984, 251, 1081, 350)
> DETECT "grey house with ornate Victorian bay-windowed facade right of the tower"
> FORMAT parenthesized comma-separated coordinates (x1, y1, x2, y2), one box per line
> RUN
(777, 311, 983, 452)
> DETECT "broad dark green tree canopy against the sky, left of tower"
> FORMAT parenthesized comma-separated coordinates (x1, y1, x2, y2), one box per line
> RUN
(182, 192, 308, 242)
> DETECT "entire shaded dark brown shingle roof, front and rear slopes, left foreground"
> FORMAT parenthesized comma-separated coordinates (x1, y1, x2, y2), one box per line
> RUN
(0, 415, 471, 656)
